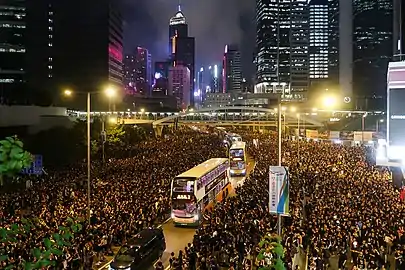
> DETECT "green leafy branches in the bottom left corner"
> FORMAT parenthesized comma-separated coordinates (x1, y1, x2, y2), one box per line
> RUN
(0, 218, 82, 270)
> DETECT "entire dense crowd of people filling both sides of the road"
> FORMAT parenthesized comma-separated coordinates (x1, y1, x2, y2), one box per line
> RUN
(0, 125, 405, 270)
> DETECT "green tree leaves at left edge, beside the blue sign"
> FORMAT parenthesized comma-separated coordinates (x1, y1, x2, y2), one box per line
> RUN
(0, 136, 33, 185)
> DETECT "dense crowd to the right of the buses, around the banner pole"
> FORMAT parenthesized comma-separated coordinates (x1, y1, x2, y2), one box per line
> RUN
(189, 131, 405, 270)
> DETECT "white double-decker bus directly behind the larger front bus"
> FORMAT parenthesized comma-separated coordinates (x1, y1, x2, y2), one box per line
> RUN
(229, 142, 246, 176)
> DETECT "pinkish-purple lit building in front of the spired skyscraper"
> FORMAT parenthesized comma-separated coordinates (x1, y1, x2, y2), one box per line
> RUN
(168, 65, 191, 109)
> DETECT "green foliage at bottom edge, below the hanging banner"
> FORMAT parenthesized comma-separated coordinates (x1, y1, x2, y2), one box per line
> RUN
(256, 234, 286, 270)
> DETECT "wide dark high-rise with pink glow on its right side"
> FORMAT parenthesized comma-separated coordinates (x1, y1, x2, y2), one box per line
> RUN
(26, 0, 123, 109)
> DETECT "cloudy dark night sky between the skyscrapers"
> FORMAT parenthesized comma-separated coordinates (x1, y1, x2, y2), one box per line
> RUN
(120, 0, 255, 78)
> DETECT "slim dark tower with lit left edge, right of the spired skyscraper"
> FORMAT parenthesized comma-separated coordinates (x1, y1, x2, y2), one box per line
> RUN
(223, 44, 242, 93)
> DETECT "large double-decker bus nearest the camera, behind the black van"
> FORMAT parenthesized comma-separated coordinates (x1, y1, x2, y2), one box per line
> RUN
(171, 158, 229, 226)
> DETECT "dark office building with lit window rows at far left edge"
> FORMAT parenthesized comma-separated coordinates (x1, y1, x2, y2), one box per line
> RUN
(0, 0, 26, 104)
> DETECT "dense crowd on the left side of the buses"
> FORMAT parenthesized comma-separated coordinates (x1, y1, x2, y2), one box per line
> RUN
(0, 130, 226, 269)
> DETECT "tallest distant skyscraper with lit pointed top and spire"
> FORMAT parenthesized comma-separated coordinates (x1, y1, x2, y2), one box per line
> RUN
(169, 6, 195, 106)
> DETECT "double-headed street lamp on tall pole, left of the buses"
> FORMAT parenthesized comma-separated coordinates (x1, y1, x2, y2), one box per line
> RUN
(63, 88, 115, 225)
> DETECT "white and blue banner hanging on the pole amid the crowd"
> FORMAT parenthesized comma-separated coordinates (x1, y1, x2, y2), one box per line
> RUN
(269, 166, 290, 215)
